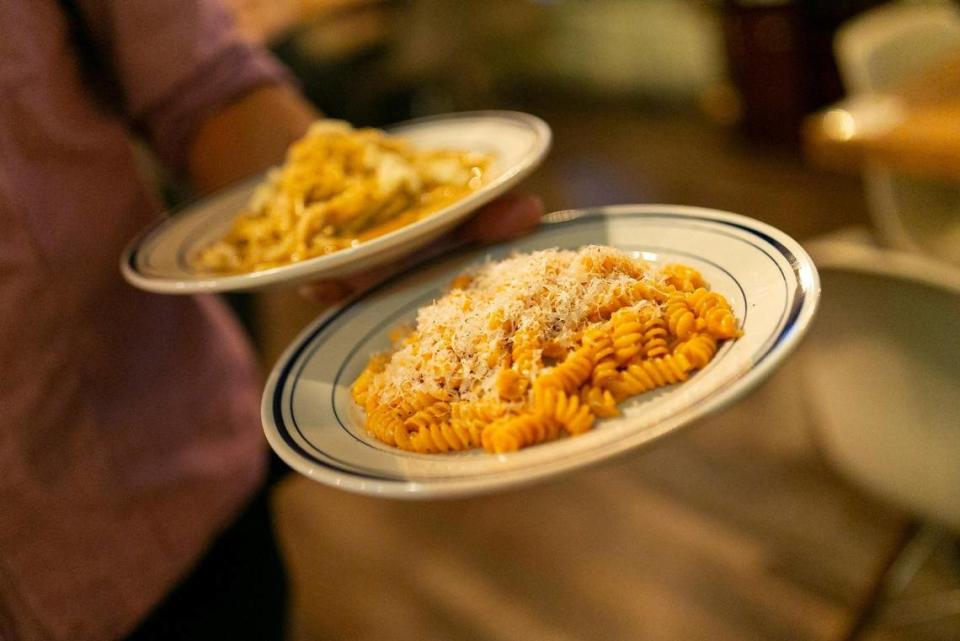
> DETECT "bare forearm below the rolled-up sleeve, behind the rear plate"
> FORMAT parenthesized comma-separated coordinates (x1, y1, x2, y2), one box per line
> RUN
(187, 85, 319, 193)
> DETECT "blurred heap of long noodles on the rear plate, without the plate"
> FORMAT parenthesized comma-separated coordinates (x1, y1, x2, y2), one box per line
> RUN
(193, 120, 492, 273)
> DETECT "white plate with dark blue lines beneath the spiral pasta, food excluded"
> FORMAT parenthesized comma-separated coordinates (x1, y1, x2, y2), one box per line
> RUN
(262, 205, 820, 499)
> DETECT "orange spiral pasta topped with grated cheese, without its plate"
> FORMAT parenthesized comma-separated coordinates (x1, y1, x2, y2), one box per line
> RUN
(352, 246, 742, 453)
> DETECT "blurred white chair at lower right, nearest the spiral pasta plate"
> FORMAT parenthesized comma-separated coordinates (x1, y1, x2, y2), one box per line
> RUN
(798, 234, 960, 639)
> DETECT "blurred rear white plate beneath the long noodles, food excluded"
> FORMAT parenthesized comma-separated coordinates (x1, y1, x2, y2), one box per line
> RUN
(120, 111, 551, 294)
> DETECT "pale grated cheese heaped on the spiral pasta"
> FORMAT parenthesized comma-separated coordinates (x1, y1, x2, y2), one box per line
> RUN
(370, 245, 676, 402)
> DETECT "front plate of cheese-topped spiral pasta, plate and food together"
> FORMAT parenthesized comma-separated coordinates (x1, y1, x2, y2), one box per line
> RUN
(262, 205, 819, 499)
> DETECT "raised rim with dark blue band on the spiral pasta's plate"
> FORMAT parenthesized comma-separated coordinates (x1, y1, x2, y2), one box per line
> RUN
(261, 204, 820, 500)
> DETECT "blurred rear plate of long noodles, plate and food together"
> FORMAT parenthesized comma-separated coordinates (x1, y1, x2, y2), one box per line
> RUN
(120, 111, 551, 294)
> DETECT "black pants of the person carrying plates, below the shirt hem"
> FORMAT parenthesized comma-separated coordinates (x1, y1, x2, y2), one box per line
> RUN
(127, 459, 288, 641)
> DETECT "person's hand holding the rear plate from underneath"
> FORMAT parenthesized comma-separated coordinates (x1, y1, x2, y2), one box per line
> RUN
(300, 194, 543, 305)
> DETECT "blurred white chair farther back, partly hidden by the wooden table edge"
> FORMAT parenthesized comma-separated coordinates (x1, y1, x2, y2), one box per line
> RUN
(834, 2, 960, 265)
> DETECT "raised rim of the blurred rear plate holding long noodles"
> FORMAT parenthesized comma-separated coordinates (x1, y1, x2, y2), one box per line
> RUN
(120, 110, 553, 294)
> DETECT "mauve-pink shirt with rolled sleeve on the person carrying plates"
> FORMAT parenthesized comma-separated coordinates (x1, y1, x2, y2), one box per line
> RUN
(0, 0, 284, 641)
